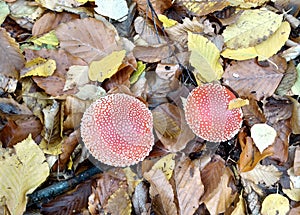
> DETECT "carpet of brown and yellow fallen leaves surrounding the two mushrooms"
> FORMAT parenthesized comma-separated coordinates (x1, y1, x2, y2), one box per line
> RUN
(0, 0, 300, 215)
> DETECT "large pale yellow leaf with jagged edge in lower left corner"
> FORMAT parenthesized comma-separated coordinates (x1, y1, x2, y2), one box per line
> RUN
(0, 135, 49, 215)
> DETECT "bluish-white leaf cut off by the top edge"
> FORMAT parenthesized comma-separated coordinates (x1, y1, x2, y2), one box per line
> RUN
(94, 0, 128, 22)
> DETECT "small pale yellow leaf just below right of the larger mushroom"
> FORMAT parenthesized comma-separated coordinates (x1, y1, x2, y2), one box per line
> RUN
(152, 154, 175, 180)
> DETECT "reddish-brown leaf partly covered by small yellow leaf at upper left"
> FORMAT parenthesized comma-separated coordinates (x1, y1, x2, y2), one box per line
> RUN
(25, 49, 87, 96)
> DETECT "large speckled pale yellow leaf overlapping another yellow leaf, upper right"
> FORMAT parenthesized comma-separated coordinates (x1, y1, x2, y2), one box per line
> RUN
(223, 9, 283, 49)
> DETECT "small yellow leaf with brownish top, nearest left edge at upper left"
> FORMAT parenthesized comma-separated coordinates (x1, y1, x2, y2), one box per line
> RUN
(21, 57, 56, 78)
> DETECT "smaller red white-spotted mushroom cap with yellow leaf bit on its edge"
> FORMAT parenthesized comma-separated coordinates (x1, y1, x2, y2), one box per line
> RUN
(185, 84, 243, 142)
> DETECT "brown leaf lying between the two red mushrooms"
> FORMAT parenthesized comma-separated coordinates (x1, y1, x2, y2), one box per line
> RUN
(152, 103, 195, 152)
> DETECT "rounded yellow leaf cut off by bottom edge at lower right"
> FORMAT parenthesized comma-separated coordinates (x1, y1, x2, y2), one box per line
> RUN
(261, 194, 290, 215)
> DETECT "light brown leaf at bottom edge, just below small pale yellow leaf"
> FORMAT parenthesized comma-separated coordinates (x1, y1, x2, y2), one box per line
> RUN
(144, 169, 177, 214)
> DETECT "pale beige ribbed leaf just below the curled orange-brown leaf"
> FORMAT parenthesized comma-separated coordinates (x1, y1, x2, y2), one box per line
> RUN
(241, 164, 282, 187)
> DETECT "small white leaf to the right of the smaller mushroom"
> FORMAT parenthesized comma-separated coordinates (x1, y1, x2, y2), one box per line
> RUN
(251, 123, 277, 153)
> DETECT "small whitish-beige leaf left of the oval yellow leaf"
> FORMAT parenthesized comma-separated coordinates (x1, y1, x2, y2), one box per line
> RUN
(63, 65, 89, 91)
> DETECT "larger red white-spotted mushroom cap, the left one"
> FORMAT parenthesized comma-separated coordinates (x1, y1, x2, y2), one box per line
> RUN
(80, 93, 154, 167)
